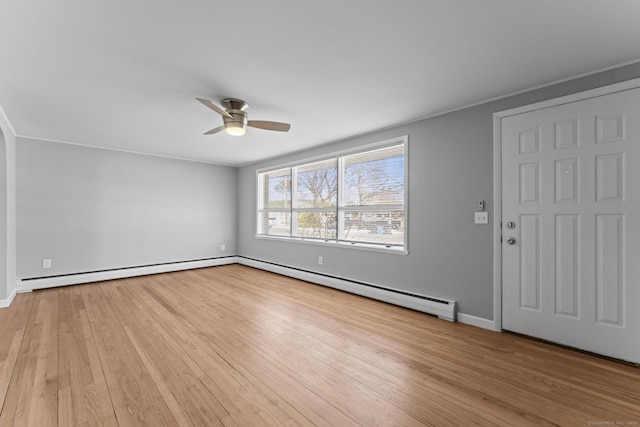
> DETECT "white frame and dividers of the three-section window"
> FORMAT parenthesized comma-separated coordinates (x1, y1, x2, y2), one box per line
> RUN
(255, 135, 409, 255)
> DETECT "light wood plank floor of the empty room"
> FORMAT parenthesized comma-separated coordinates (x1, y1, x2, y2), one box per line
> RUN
(0, 265, 640, 427)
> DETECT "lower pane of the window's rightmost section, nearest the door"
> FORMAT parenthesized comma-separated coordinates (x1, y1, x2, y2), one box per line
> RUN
(340, 211, 405, 246)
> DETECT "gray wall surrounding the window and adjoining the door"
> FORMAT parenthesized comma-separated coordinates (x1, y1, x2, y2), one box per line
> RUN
(238, 64, 640, 319)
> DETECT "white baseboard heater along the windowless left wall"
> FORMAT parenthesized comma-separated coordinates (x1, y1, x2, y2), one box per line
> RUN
(18, 256, 237, 292)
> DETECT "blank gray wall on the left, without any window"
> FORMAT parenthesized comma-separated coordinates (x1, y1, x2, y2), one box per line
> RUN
(16, 138, 238, 278)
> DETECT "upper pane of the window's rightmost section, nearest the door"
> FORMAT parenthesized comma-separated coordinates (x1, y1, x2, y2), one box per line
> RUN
(342, 145, 404, 206)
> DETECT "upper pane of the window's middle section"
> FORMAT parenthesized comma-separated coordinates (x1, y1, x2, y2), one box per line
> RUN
(295, 159, 338, 208)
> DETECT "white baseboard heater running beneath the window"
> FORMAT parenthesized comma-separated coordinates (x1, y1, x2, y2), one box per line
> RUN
(237, 256, 457, 322)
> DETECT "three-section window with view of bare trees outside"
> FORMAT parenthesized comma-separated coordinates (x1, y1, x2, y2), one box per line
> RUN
(258, 137, 407, 250)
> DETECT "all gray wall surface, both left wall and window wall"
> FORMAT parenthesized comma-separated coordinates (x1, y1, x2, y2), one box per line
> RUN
(12, 64, 640, 319)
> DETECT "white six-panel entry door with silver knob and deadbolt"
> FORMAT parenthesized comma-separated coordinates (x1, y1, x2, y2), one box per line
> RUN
(501, 88, 640, 363)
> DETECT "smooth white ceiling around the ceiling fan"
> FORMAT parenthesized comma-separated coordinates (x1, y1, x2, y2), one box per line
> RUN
(0, 0, 640, 165)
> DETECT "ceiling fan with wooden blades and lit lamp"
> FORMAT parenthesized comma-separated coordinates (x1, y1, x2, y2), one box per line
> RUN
(196, 98, 291, 136)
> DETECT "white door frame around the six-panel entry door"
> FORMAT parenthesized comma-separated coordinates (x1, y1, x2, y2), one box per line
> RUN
(493, 78, 640, 332)
